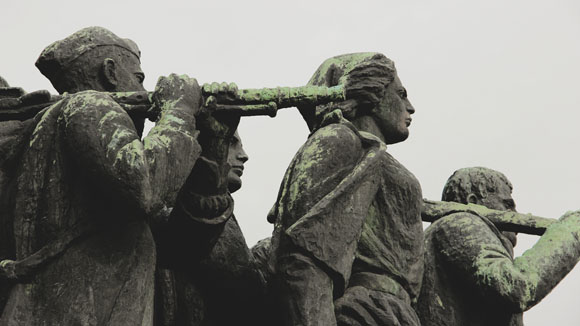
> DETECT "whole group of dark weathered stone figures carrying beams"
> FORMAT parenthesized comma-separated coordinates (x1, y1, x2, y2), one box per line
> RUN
(0, 27, 580, 326)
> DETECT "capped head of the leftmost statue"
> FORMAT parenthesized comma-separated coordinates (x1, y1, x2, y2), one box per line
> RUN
(36, 27, 145, 94)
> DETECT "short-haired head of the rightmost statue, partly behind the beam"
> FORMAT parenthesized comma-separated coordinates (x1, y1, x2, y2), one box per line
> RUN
(441, 167, 517, 246)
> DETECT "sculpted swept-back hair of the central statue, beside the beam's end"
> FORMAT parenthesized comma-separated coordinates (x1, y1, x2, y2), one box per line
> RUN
(298, 52, 397, 130)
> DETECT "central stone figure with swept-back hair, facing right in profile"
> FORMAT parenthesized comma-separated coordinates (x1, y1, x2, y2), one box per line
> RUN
(269, 53, 423, 326)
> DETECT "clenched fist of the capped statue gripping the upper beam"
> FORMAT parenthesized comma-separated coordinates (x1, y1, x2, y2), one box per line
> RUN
(153, 74, 201, 115)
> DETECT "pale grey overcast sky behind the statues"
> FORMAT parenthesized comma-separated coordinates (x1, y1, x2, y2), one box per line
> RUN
(0, 0, 580, 326)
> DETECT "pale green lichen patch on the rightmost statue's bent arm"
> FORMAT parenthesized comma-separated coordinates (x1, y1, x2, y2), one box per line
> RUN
(442, 212, 580, 311)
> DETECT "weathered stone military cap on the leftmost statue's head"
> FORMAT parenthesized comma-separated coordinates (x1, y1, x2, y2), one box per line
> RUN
(36, 26, 141, 80)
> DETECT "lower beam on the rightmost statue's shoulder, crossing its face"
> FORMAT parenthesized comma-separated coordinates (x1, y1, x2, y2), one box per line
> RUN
(421, 199, 558, 235)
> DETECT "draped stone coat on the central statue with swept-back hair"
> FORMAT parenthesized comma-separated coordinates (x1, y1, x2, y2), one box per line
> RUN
(269, 115, 423, 325)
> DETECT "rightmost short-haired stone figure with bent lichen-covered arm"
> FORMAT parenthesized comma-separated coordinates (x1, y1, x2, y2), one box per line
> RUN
(417, 167, 580, 326)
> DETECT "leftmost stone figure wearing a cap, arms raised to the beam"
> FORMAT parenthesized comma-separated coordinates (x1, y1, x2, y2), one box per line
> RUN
(0, 27, 235, 325)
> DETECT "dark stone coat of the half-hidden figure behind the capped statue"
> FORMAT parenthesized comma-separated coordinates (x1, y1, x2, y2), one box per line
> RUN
(155, 216, 267, 326)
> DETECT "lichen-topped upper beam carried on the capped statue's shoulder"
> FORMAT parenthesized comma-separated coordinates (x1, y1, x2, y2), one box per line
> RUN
(0, 84, 345, 121)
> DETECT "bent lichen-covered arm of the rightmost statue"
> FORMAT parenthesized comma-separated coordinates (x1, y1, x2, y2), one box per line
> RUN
(437, 212, 580, 312)
